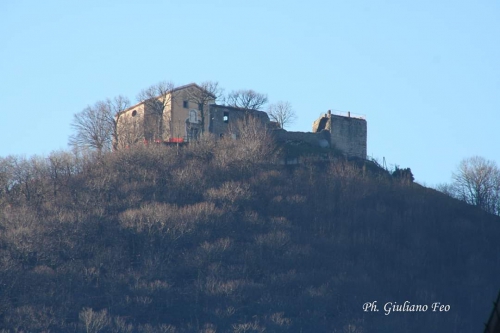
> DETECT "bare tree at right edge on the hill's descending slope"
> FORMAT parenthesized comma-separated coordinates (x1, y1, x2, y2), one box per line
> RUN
(447, 156, 500, 214)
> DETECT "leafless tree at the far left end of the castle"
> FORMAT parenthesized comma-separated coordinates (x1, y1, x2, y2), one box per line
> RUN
(69, 102, 113, 154)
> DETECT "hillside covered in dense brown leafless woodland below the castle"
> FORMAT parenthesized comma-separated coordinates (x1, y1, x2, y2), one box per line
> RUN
(0, 136, 500, 333)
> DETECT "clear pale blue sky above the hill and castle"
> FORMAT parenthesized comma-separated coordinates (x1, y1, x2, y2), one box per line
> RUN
(0, 0, 500, 186)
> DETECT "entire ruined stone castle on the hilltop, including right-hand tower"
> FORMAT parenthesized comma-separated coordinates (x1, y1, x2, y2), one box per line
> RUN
(116, 83, 367, 159)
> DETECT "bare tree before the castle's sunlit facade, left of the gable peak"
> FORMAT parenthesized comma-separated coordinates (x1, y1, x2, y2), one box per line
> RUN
(137, 81, 175, 140)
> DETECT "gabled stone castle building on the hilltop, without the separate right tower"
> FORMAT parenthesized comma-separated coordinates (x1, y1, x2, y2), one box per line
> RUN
(116, 83, 269, 147)
